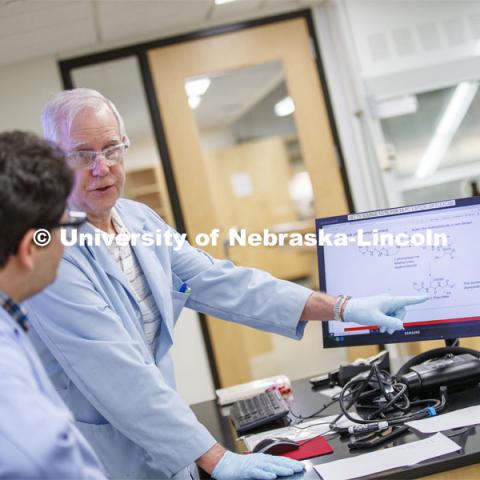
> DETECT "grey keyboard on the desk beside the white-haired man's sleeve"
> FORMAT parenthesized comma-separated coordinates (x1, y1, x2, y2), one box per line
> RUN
(230, 390, 290, 435)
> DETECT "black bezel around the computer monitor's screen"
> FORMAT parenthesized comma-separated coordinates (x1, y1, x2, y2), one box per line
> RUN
(315, 197, 480, 348)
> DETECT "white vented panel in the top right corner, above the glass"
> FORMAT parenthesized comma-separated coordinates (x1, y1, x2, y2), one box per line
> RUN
(344, 0, 480, 85)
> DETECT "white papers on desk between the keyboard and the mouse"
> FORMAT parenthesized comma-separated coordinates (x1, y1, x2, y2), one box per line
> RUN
(243, 413, 358, 451)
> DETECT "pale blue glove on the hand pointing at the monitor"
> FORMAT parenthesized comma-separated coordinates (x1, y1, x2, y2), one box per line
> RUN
(343, 293, 428, 333)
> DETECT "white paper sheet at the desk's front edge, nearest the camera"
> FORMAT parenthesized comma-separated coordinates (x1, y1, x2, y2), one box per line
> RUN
(313, 433, 461, 480)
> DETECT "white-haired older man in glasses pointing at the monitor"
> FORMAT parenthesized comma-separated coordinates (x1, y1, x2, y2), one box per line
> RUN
(26, 89, 424, 480)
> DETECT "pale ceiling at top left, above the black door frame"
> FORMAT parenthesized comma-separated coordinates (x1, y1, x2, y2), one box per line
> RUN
(0, 0, 323, 65)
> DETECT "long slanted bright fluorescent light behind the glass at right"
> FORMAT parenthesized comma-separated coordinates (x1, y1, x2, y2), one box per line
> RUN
(415, 82, 478, 178)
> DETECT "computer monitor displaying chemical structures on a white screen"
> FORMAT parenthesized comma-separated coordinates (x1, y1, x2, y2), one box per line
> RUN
(316, 197, 480, 348)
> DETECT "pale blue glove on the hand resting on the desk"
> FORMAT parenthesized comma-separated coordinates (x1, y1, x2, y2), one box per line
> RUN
(212, 451, 305, 480)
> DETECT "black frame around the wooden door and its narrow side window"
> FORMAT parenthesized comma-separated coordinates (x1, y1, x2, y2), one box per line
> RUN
(58, 9, 355, 388)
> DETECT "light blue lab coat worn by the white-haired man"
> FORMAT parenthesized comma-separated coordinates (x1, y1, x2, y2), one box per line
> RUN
(28, 199, 312, 478)
